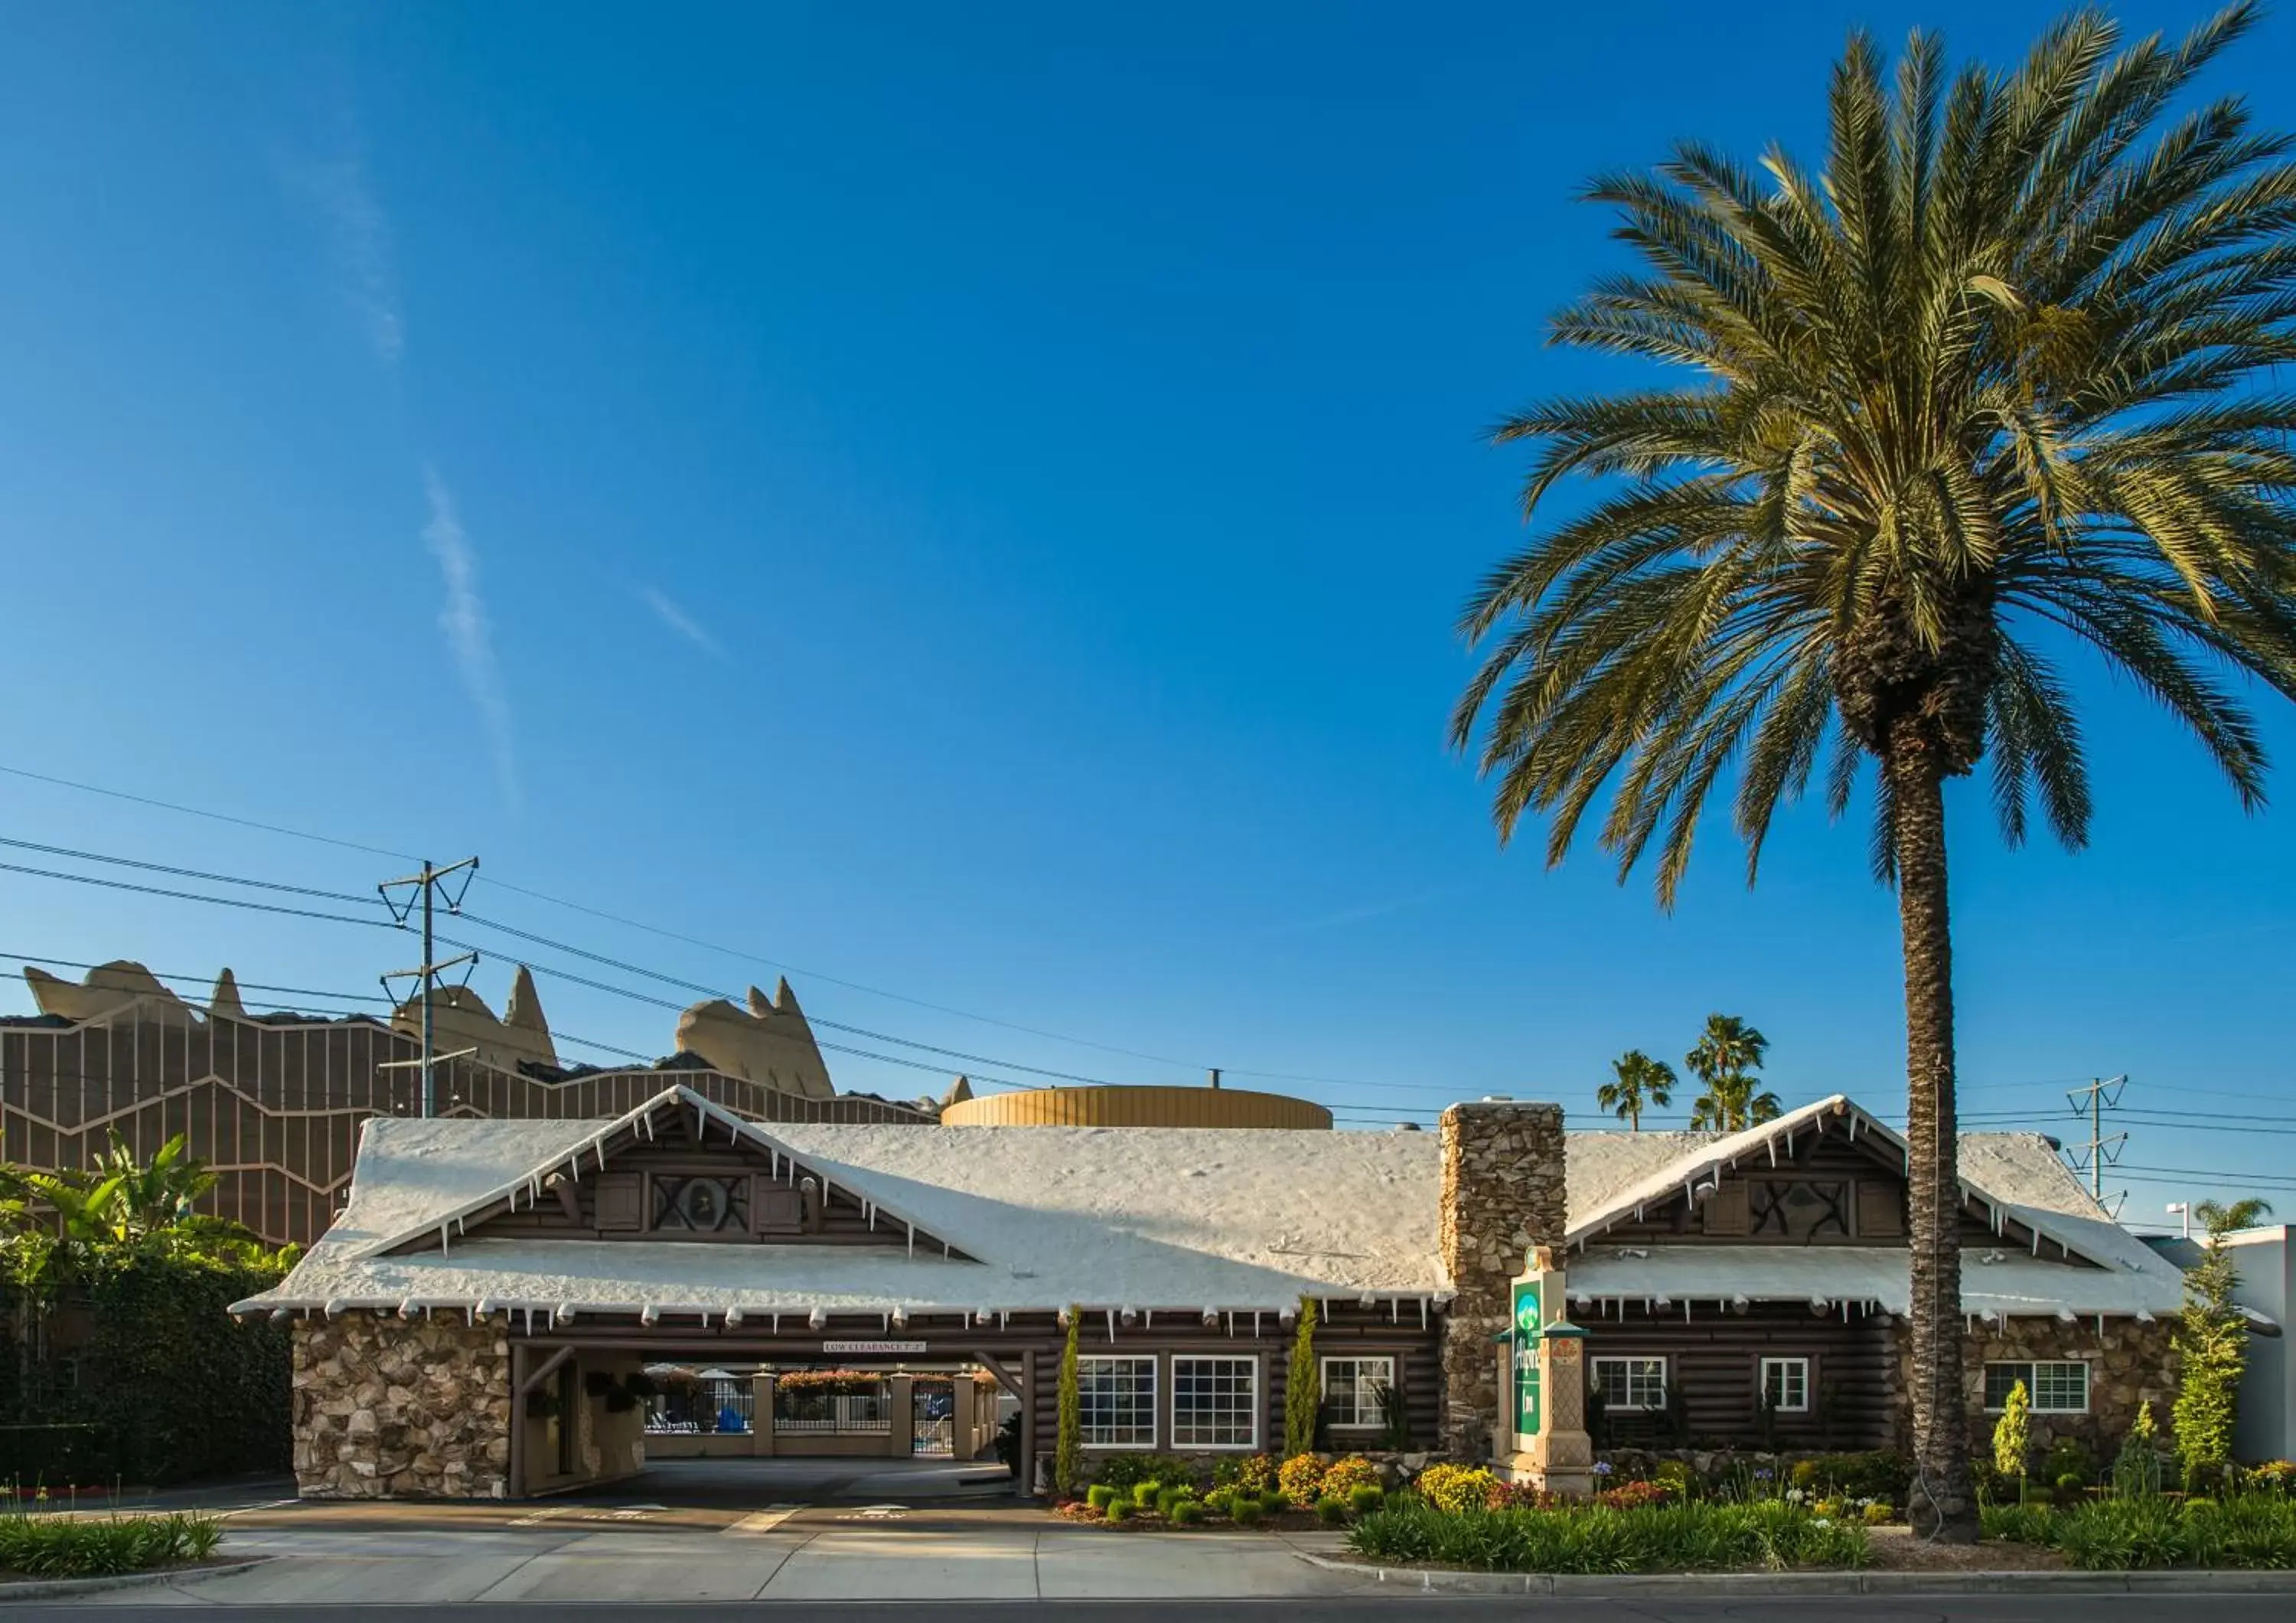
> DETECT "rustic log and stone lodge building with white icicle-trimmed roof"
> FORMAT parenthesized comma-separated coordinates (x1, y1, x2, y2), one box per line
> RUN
(234, 1086, 2181, 1497)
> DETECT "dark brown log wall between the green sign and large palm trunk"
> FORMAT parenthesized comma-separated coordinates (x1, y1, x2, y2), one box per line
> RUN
(1573, 1301, 1899, 1448)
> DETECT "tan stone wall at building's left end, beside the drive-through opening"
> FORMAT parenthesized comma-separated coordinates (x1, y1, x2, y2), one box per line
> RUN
(294, 1313, 510, 1499)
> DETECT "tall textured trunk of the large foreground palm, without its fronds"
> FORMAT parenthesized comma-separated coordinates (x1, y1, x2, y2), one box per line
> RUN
(1883, 740, 1977, 1543)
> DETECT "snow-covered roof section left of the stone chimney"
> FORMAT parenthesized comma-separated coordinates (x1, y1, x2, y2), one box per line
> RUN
(243, 1088, 1449, 1318)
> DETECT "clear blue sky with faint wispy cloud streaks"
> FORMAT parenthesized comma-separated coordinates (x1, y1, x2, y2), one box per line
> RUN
(0, 0, 2296, 1219)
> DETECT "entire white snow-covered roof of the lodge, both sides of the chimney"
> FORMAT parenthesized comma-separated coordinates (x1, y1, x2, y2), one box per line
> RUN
(243, 1088, 2181, 1318)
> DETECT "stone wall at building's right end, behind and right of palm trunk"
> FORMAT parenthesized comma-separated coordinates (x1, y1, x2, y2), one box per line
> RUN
(1896, 1318, 2177, 1469)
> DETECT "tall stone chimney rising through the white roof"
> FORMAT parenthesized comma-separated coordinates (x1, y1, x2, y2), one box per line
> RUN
(1442, 1099, 1568, 1460)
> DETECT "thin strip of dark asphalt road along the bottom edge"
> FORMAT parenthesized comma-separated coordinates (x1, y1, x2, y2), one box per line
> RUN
(7, 1593, 2296, 1623)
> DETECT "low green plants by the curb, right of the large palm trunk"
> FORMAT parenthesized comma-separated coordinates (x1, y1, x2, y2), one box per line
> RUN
(1981, 1492, 2296, 1572)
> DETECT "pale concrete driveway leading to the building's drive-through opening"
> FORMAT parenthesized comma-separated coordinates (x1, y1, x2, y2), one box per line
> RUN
(85, 1501, 1375, 1607)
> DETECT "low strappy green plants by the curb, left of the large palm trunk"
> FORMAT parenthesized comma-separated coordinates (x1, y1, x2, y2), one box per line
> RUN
(1348, 1497, 1867, 1572)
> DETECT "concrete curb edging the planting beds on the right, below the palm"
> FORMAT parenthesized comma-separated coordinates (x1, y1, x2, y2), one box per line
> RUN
(1293, 1545, 2296, 1600)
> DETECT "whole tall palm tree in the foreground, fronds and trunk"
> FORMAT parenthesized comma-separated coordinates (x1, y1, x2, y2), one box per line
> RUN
(1453, 2, 2296, 1540)
